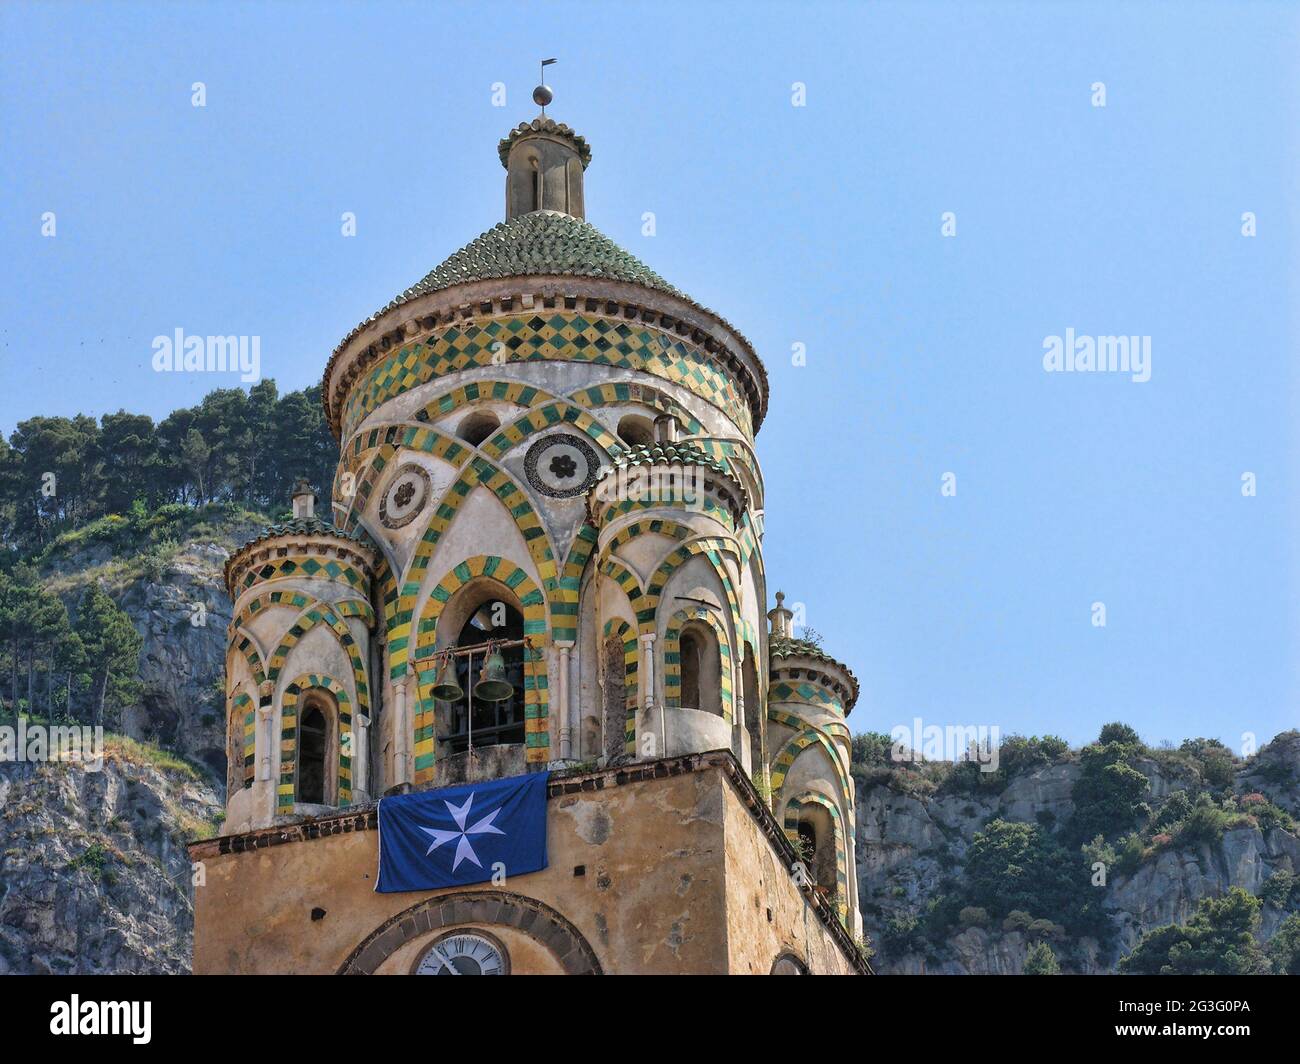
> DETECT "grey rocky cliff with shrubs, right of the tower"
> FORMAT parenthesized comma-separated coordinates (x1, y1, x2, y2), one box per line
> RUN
(857, 732, 1300, 974)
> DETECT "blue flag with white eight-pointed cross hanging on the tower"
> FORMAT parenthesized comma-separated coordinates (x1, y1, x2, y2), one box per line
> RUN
(374, 773, 551, 894)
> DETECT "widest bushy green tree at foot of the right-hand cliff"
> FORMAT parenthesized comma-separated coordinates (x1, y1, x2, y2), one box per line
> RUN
(1119, 887, 1270, 976)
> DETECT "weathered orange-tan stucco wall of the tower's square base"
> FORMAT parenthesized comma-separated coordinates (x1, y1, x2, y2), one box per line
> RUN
(192, 754, 849, 974)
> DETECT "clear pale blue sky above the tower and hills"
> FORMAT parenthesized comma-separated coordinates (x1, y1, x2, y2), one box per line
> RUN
(0, 0, 1300, 748)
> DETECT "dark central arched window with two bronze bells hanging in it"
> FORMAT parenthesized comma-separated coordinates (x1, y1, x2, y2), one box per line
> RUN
(442, 598, 525, 753)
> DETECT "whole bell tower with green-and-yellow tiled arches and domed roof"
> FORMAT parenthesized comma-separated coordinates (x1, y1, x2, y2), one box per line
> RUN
(191, 87, 870, 974)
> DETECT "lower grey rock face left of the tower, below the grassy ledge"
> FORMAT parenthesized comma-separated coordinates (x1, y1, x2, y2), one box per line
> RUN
(0, 741, 221, 974)
